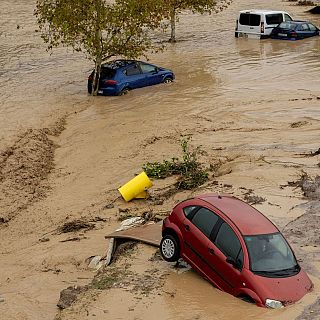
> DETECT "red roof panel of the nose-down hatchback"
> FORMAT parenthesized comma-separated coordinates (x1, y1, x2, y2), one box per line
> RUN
(195, 193, 279, 235)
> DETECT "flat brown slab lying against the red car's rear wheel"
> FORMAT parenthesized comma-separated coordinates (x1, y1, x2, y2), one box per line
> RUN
(105, 221, 162, 247)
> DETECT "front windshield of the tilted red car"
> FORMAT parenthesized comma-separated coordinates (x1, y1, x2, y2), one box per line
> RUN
(244, 233, 300, 276)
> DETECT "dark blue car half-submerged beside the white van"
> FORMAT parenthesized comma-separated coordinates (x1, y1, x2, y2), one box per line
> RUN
(271, 20, 319, 40)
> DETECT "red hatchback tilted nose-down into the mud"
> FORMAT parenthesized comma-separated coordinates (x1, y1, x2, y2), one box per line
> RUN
(160, 194, 313, 308)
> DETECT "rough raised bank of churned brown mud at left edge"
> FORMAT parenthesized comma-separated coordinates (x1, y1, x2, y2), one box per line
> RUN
(0, 118, 65, 223)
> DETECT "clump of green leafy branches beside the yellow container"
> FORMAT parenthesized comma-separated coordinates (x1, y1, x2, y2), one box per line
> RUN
(142, 139, 208, 190)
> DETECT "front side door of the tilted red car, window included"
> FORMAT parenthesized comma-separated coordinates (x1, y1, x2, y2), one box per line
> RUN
(206, 222, 245, 293)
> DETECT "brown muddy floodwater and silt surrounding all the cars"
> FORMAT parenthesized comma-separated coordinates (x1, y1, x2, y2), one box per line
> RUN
(0, 0, 320, 320)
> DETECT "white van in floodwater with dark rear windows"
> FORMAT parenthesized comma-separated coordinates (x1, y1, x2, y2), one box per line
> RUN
(235, 10, 292, 39)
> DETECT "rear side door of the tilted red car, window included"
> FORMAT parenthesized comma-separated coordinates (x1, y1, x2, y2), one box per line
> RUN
(182, 207, 219, 283)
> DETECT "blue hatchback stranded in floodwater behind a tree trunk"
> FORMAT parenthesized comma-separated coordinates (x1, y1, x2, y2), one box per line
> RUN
(88, 60, 175, 96)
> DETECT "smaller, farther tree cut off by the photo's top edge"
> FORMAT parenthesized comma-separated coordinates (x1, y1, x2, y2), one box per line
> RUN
(163, 0, 216, 42)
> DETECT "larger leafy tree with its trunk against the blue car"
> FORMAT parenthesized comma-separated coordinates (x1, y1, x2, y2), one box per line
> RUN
(35, 0, 163, 95)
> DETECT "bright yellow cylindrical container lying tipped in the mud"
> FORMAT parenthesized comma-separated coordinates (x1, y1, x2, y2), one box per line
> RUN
(118, 171, 152, 202)
